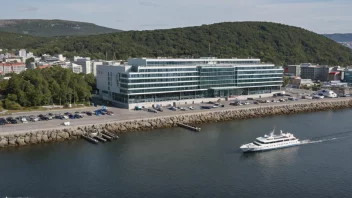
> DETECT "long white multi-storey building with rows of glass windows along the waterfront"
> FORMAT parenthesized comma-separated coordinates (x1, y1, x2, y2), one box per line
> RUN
(96, 57, 283, 108)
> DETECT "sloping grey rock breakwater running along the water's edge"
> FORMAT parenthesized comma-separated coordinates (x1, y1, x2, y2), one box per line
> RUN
(0, 100, 352, 147)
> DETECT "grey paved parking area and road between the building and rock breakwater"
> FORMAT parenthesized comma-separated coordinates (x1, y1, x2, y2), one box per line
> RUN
(0, 91, 351, 136)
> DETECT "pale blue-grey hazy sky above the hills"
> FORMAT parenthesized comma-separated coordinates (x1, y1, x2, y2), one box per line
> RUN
(0, 0, 352, 34)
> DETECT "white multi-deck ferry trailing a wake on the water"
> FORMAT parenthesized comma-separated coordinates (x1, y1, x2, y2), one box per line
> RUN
(240, 129, 300, 152)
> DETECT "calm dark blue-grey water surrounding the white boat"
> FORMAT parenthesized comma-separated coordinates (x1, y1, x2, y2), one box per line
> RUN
(0, 110, 352, 198)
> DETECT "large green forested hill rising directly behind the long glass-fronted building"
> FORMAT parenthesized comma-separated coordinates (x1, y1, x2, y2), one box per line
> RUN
(0, 22, 352, 65)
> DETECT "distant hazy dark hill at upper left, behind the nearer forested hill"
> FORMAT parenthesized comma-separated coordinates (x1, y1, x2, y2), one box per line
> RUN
(0, 19, 121, 37)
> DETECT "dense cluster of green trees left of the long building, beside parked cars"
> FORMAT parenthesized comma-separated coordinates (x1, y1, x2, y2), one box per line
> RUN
(0, 66, 96, 109)
